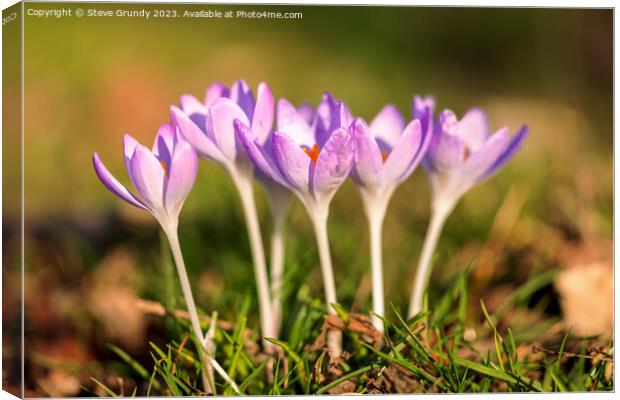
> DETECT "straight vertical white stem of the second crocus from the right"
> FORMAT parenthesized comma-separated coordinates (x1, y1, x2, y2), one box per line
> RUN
(362, 192, 390, 333)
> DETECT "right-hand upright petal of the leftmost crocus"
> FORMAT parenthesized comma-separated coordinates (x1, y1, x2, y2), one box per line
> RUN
(164, 140, 198, 216)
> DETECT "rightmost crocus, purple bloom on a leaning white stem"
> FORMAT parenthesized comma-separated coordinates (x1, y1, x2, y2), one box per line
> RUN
(409, 103, 527, 316)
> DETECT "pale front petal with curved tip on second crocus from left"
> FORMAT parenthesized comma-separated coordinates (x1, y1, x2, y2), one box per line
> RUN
(207, 98, 250, 162)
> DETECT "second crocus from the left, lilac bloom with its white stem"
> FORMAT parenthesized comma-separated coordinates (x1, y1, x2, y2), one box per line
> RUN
(171, 80, 277, 349)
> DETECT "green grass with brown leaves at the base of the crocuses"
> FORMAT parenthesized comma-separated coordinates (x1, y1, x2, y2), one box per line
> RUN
(95, 269, 614, 396)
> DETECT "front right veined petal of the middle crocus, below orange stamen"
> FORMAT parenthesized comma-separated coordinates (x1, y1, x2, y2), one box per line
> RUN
(312, 128, 355, 201)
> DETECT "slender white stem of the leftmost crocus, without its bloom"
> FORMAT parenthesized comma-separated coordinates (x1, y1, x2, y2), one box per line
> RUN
(164, 226, 215, 394)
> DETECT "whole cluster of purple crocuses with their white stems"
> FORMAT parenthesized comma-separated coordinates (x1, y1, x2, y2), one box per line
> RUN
(93, 81, 527, 372)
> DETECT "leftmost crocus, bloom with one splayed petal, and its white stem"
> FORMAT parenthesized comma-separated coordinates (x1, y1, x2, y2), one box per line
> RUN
(93, 124, 238, 392)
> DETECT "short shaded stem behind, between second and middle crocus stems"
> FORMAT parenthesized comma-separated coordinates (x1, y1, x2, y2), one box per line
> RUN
(270, 207, 286, 334)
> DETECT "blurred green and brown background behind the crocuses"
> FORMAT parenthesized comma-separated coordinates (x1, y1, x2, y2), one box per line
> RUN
(3, 3, 613, 396)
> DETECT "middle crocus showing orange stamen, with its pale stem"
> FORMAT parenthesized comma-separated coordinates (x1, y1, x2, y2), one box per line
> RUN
(235, 93, 355, 354)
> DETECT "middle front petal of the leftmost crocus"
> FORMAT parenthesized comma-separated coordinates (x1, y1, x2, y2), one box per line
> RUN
(130, 145, 166, 214)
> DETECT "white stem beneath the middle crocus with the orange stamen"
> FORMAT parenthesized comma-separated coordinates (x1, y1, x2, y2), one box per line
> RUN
(309, 206, 342, 356)
